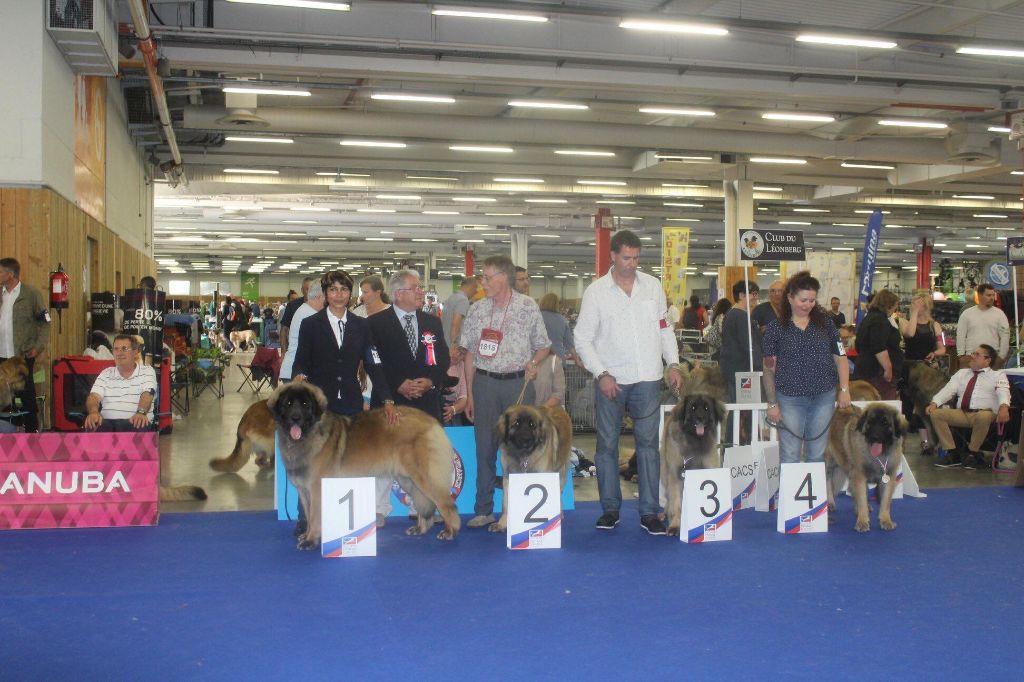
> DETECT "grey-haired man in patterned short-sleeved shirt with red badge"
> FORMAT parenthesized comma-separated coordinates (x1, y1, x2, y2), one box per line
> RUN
(460, 256, 551, 530)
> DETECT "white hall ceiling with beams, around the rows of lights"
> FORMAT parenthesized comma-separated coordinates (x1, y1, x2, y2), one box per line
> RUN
(123, 0, 1024, 274)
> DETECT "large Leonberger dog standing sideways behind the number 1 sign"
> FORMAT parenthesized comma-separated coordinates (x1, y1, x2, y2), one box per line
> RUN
(267, 382, 461, 549)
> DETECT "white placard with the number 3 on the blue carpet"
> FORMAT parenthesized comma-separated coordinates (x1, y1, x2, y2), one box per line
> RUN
(679, 467, 732, 543)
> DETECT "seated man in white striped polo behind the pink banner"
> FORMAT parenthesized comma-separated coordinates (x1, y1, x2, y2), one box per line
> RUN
(84, 334, 157, 431)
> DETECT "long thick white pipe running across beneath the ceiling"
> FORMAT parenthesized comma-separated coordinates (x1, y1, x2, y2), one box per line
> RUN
(183, 106, 948, 163)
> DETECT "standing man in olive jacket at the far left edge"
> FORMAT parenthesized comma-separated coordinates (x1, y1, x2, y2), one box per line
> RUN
(0, 258, 50, 433)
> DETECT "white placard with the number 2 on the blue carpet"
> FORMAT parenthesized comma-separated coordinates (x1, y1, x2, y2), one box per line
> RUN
(505, 473, 562, 550)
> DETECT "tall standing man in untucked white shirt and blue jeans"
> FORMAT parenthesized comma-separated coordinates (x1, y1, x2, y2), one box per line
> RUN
(574, 229, 682, 536)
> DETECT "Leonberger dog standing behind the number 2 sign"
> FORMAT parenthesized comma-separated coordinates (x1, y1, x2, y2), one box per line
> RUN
(487, 404, 572, 532)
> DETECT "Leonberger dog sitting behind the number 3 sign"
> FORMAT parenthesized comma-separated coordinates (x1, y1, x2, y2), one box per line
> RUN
(662, 368, 725, 536)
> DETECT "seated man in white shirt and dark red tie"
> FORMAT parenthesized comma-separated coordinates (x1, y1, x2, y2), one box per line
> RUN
(925, 343, 1010, 469)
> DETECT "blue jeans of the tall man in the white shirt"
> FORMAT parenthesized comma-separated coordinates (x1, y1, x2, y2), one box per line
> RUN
(594, 381, 662, 516)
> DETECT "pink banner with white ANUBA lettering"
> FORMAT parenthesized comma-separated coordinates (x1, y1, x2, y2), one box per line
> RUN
(0, 432, 160, 530)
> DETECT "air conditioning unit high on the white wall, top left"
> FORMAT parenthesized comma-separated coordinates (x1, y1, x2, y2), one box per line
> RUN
(46, 0, 118, 77)
